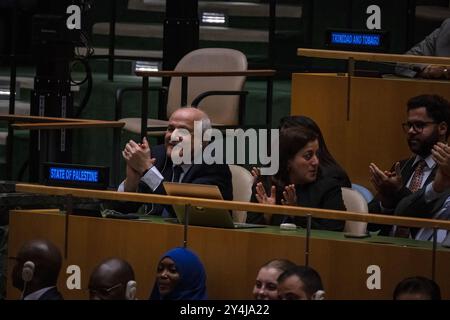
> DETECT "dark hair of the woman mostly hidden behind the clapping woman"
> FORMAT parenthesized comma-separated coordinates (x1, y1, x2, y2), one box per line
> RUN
(280, 116, 351, 187)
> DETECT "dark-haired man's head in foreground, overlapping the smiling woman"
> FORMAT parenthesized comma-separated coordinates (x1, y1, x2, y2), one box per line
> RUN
(278, 266, 325, 300)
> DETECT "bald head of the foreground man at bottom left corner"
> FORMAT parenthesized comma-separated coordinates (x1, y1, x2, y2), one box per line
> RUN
(13, 239, 62, 290)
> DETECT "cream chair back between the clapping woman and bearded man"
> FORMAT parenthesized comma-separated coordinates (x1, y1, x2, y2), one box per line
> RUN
(341, 188, 369, 234)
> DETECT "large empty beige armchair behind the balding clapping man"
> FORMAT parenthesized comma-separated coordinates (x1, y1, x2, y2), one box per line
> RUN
(118, 48, 247, 134)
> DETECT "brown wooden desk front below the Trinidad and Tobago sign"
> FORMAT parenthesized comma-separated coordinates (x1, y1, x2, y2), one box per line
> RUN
(291, 73, 450, 188)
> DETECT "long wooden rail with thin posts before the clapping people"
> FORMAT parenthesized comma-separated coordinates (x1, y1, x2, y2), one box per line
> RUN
(16, 184, 450, 279)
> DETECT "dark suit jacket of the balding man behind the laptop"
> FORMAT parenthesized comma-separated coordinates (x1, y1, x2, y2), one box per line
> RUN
(118, 145, 233, 217)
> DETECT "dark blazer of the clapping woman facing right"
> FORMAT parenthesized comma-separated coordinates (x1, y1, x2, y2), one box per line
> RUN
(247, 177, 346, 231)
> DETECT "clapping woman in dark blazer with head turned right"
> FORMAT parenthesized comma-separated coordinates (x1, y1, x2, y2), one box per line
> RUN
(247, 127, 346, 231)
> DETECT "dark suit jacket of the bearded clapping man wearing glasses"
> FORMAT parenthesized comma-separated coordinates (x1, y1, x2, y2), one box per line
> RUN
(368, 156, 437, 235)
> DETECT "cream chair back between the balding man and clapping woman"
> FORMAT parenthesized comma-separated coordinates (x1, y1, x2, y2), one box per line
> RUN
(229, 164, 253, 222)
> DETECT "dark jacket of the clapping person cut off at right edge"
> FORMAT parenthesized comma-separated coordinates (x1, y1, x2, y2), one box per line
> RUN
(395, 188, 450, 237)
